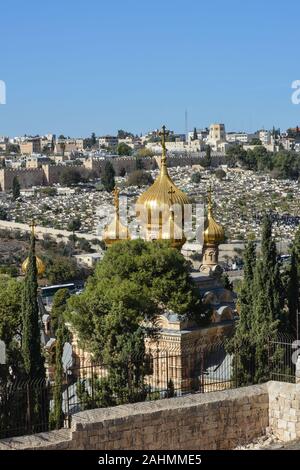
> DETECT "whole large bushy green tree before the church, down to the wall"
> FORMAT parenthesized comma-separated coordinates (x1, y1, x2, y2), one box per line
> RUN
(68, 240, 209, 406)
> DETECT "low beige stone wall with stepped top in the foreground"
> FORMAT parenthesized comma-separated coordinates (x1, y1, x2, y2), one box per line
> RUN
(0, 382, 300, 450)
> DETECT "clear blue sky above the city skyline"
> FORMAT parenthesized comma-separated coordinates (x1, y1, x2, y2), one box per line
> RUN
(0, 0, 300, 136)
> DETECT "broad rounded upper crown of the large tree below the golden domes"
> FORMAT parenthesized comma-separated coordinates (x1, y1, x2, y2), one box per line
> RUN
(69, 240, 209, 360)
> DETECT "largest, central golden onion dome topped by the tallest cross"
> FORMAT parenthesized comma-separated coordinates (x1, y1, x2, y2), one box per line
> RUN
(136, 126, 190, 246)
